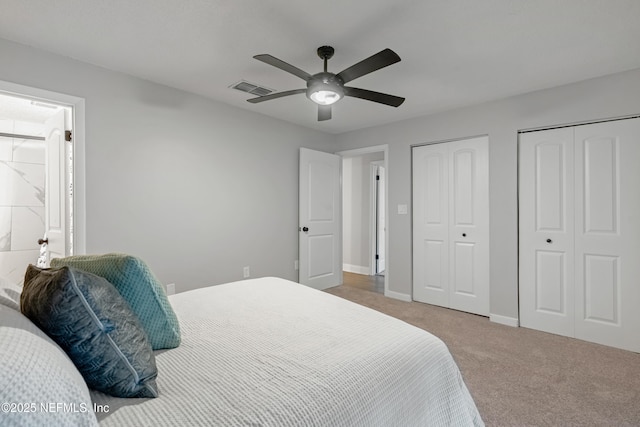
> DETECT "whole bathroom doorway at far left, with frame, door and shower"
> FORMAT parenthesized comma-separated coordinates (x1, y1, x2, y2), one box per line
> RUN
(0, 82, 84, 284)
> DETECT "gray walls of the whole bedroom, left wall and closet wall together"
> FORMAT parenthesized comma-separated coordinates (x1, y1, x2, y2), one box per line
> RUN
(5, 40, 640, 318)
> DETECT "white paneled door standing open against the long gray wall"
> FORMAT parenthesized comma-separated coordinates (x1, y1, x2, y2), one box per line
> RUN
(299, 148, 342, 289)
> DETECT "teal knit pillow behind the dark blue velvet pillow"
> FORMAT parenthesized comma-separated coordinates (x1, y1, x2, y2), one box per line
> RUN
(51, 253, 180, 350)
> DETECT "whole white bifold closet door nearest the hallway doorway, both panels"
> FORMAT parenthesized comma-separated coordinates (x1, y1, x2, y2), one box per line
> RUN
(412, 137, 489, 316)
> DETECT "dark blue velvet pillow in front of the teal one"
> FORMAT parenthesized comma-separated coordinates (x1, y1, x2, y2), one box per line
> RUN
(20, 265, 158, 397)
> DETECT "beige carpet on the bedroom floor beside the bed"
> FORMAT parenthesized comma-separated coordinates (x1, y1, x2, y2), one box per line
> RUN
(327, 286, 640, 426)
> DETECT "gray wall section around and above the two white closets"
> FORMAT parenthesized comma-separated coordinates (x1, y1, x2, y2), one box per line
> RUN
(338, 70, 640, 318)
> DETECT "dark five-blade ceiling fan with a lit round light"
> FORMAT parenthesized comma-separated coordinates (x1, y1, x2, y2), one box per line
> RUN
(247, 46, 404, 121)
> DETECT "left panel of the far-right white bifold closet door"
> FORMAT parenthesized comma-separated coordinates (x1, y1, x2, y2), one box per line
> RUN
(519, 128, 574, 336)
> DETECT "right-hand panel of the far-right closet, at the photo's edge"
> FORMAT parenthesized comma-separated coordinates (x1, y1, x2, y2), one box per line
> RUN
(575, 119, 640, 351)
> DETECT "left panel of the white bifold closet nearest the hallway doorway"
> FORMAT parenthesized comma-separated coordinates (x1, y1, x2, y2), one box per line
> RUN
(413, 144, 449, 307)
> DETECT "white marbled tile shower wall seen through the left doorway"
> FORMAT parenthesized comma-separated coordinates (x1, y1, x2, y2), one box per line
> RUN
(0, 118, 45, 283)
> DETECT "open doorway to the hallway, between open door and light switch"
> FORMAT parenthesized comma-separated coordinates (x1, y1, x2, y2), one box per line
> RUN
(337, 145, 389, 293)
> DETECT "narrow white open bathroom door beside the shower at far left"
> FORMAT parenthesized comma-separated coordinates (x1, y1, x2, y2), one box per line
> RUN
(45, 108, 69, 266)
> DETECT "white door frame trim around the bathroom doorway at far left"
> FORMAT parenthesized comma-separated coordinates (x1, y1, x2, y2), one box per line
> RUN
(0, 80, 87, 254)
